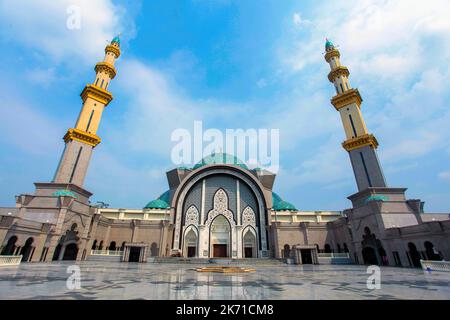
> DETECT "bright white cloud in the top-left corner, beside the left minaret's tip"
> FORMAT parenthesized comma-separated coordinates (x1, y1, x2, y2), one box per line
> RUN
(0, 0, 134, 64)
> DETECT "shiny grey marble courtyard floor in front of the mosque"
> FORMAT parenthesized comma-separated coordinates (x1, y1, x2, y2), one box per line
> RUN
(0, 261, 450, 300)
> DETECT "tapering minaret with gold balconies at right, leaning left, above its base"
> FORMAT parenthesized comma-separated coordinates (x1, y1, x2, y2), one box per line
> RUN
(325, 39, 386, 191)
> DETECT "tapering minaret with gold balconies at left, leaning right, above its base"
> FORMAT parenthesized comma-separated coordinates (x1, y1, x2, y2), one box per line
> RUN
(53, 36, 120, 187)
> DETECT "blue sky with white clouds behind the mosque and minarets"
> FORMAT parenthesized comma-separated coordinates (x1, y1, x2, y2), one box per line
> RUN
(0, 0, 450, 212)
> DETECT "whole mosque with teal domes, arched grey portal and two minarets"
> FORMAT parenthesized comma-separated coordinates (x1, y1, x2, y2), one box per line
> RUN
(0, 37, 450, 267)
